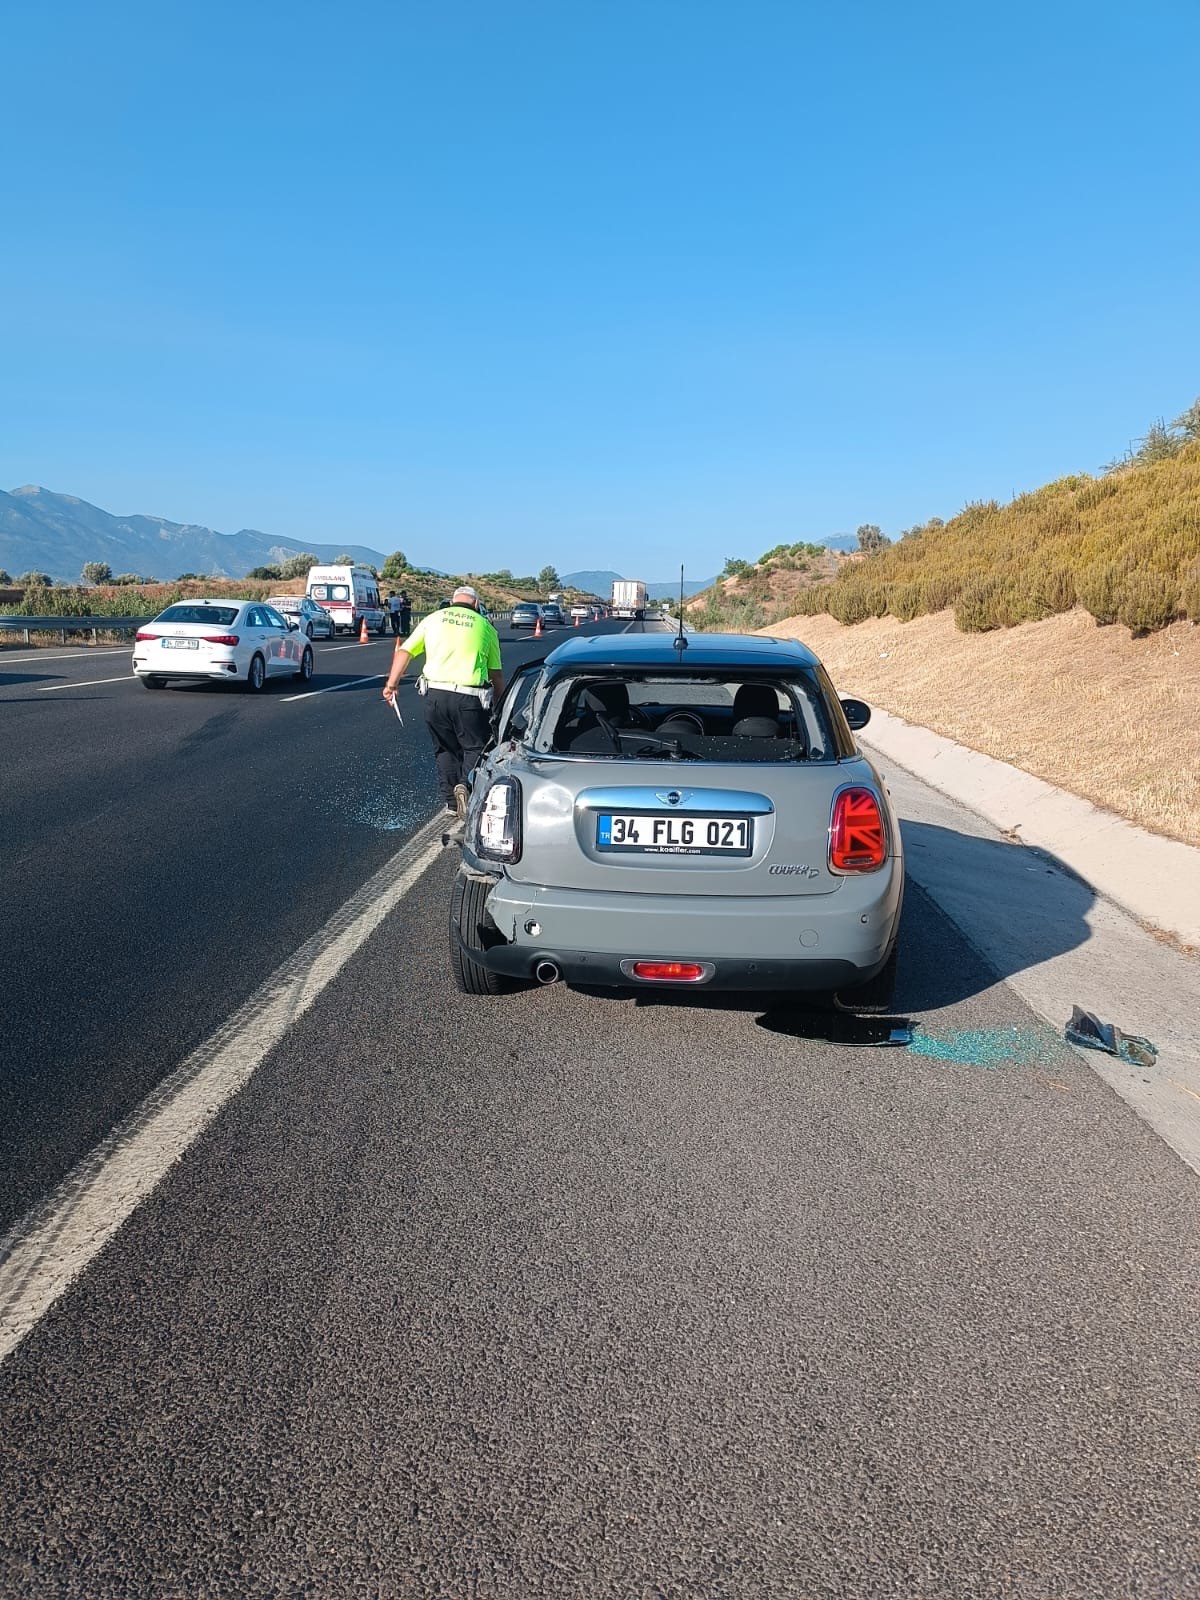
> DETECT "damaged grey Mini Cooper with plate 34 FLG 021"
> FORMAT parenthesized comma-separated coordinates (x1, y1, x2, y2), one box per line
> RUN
(450, 632, 904, 1010)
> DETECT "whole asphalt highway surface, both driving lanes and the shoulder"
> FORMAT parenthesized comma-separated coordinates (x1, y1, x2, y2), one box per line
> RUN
(0, 617, 1200, 1600)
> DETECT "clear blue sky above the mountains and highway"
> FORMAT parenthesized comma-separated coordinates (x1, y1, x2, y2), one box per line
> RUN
(0, 0, 1200, 579)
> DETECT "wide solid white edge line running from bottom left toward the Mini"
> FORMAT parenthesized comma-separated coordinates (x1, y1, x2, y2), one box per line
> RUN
(0, 814, 445, 1363)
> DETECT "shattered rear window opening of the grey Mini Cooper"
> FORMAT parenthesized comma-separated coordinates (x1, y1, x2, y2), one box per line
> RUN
(530, 674, 838, 762)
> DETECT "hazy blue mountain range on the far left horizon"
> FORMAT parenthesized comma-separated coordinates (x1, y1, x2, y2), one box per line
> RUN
(0, 483, 384, 584)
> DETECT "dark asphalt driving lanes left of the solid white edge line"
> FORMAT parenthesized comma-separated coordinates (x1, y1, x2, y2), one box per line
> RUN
(0, 624, 619, 1232)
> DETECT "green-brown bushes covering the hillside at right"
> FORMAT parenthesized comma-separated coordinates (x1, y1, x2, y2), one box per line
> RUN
(691, 403, 1200, 635)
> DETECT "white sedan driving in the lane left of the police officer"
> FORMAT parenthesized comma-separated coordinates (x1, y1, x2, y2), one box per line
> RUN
(133, 600, 312, 693)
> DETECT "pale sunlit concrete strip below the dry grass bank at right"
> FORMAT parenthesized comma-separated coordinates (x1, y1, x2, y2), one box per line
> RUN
(862, 710, 1200, 949)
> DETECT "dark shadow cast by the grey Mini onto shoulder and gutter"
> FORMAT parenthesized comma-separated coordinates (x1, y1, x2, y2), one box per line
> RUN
(579, 822, 1096, 1045)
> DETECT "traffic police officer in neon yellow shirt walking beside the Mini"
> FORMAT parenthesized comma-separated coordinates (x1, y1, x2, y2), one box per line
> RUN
(384, 584, 504, 840)
